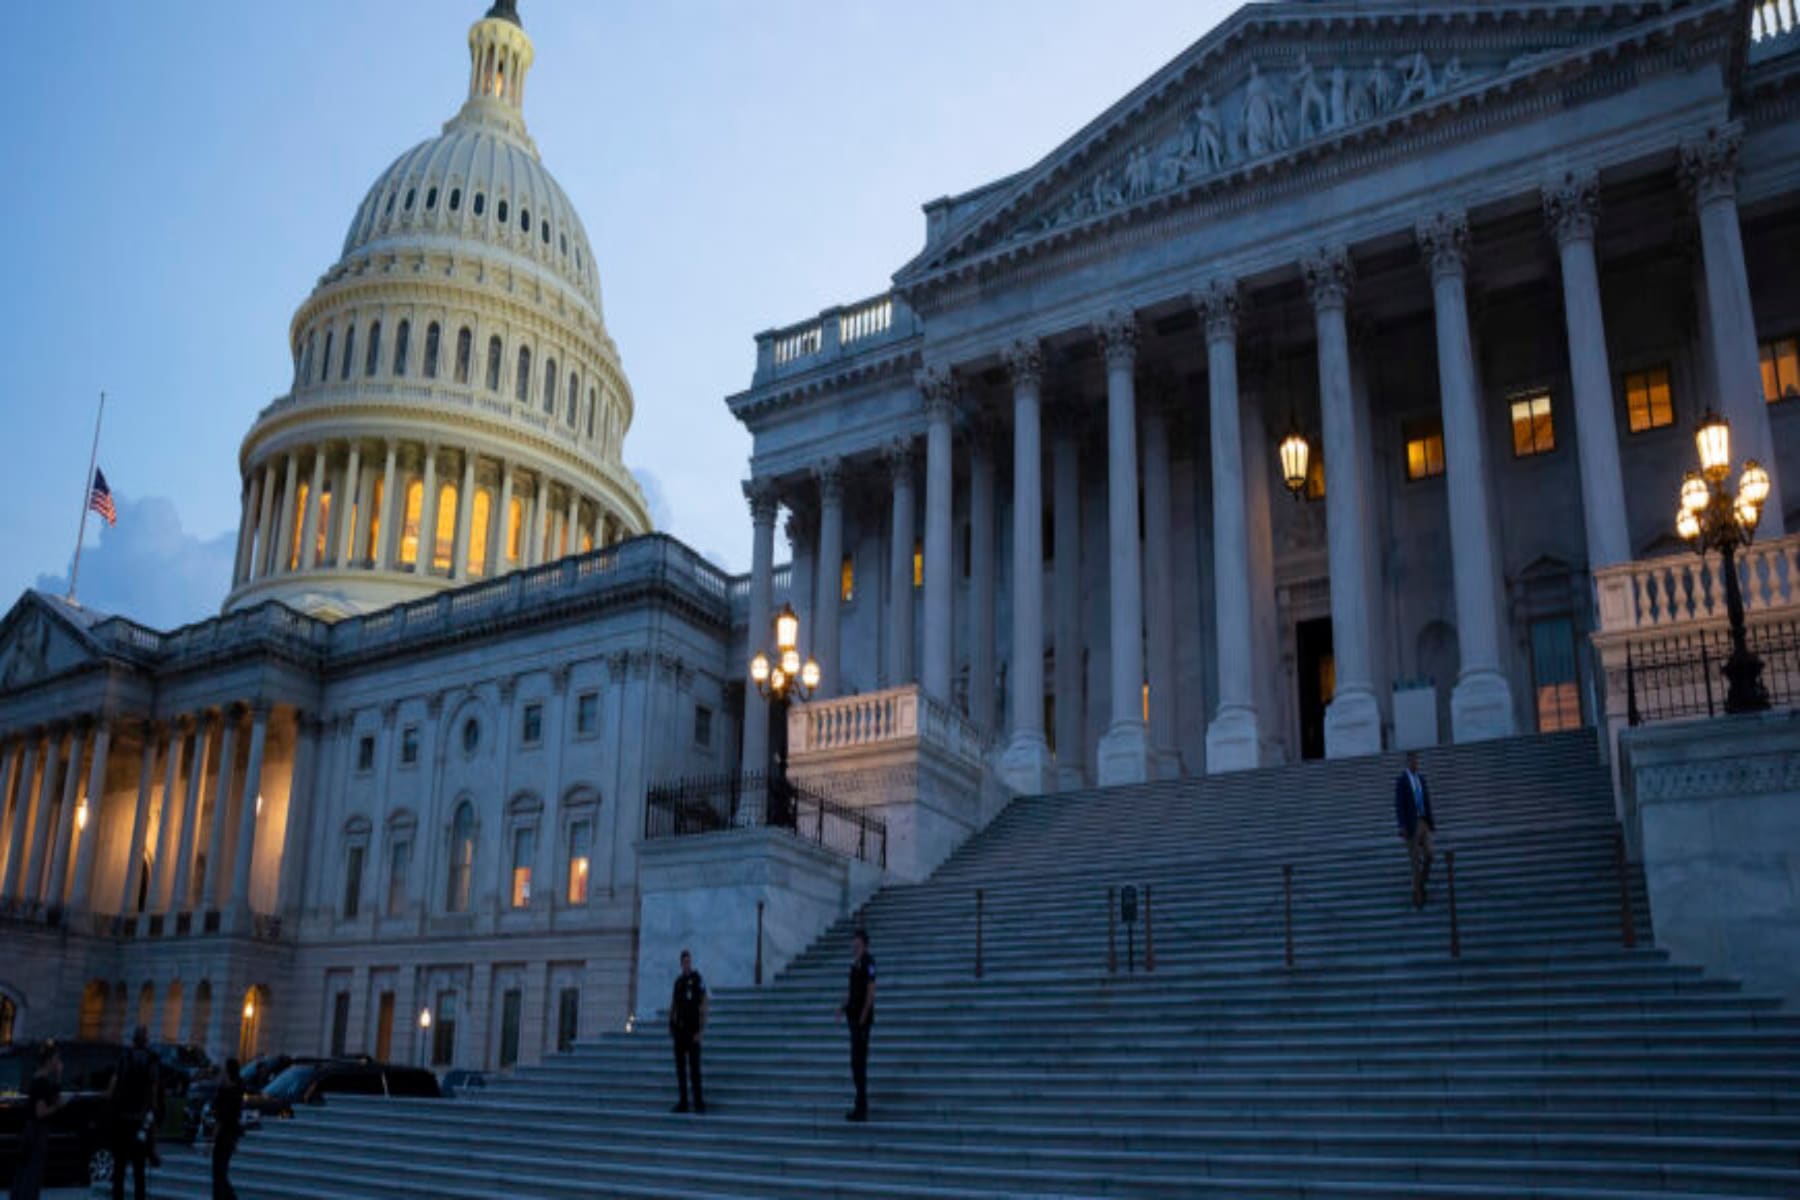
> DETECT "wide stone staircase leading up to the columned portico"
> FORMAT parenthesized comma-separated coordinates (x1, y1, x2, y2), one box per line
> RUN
(158, 732, 1800, 1200)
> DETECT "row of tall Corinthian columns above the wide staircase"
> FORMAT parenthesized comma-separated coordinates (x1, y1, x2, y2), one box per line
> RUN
(745, 128, 1780, 792)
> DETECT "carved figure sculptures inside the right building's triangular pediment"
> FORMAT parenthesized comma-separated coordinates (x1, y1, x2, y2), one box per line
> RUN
(1012, 50, 1471, 239)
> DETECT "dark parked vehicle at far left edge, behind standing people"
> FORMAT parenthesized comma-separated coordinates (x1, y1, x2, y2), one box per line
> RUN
(0, 1040, 124, 1187)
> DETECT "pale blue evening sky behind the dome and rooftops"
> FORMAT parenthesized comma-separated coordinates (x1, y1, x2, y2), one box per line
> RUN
(0, 0, 1235, 626)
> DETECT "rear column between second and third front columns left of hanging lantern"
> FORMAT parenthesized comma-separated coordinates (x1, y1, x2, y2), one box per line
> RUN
(1049, 420, 1087, 792)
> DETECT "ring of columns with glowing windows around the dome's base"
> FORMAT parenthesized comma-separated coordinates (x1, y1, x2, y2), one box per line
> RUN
(232, 441, 623, 585)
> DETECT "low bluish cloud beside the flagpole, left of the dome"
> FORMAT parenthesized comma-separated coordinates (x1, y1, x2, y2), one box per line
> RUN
(36, 493, 238, 630)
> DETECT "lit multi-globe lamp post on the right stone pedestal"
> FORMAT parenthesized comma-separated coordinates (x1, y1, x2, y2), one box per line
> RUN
(1676, 412, 1769, 712)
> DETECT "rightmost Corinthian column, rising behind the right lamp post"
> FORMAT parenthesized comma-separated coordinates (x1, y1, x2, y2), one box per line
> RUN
(1681, 121, 1786, 538)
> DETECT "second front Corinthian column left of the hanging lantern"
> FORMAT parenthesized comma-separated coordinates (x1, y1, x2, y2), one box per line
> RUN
(1094, 313, 1148, 786)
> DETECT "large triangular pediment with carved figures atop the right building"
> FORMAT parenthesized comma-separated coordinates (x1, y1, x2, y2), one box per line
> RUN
(895, 0, 1735, 290)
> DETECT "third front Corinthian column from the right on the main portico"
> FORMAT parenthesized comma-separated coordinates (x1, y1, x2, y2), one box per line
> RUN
(1418, 212, 1514, 741)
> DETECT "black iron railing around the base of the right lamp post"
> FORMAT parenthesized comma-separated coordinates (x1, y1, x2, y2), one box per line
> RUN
(1613, 621, 1800, 725)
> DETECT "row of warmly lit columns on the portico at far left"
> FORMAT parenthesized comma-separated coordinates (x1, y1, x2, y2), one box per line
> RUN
(0, 702, 272, 927)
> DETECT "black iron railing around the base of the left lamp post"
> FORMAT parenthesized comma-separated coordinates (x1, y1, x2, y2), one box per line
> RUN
(644, 772, 887, 867)
